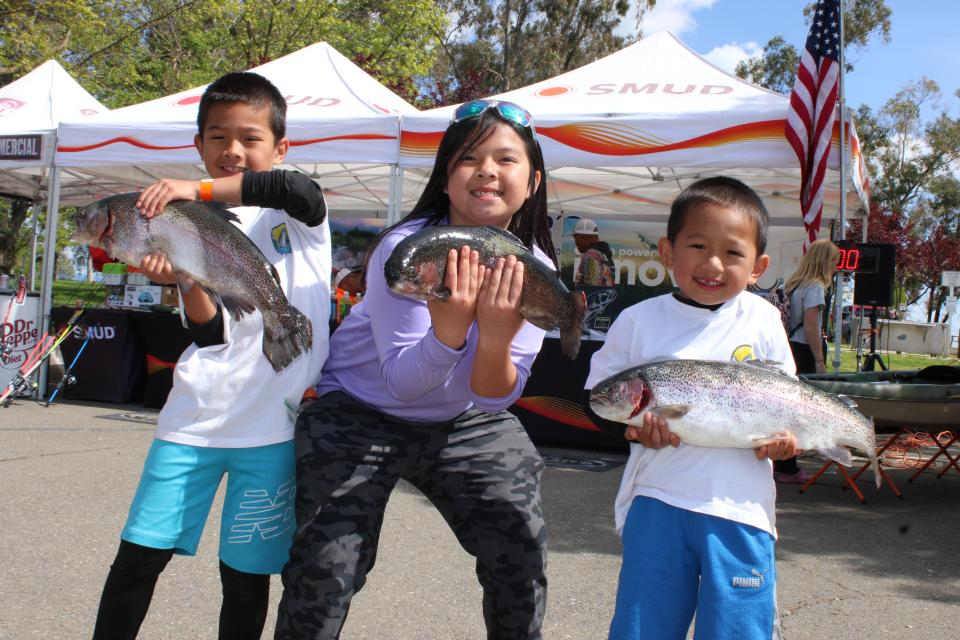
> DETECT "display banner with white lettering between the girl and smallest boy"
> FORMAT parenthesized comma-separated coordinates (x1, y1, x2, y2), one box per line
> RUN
(560, 215, 673, 339)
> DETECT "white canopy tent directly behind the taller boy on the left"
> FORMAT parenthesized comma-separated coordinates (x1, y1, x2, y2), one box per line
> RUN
(41, 42, 417, 396)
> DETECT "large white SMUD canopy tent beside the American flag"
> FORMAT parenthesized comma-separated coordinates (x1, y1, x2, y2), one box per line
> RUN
(400, 32, 866, 286)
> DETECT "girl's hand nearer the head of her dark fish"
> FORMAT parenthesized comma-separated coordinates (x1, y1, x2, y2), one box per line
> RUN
(427, 246, 484, 349)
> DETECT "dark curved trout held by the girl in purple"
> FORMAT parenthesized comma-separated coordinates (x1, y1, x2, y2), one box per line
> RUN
(384, 226, 587, 360)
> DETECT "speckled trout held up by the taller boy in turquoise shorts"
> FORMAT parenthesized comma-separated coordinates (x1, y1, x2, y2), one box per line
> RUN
(73, 193, 313, 371)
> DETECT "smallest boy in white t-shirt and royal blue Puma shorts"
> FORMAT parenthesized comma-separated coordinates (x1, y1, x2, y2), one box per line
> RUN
(586, 177, 796, 640)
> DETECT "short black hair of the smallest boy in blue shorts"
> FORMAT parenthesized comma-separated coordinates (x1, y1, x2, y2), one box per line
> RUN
(667, 176, 770, 256)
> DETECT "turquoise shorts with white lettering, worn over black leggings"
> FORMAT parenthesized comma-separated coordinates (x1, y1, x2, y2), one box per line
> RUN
(120, 440, 296, 574)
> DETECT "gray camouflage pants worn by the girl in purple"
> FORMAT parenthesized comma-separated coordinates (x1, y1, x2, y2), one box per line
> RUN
(275, 392, 547, 640)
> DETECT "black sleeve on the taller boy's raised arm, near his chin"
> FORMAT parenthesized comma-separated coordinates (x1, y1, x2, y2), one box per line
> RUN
(240, 169, 327, 227)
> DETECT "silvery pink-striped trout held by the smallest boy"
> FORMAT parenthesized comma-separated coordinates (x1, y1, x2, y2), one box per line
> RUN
(590, 360, 880, 488)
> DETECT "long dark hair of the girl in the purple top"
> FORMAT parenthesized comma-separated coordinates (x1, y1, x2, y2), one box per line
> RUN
(366, 109, 557, 267)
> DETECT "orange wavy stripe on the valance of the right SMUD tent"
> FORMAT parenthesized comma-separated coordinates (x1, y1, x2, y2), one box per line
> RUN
(400, 120, 839, 157)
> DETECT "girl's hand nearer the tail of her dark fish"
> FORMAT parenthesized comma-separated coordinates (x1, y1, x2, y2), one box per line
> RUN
(477, 256, 523, 350)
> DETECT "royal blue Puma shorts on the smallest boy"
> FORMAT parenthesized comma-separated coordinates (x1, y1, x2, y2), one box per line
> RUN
(610, 496, 779, 640)
